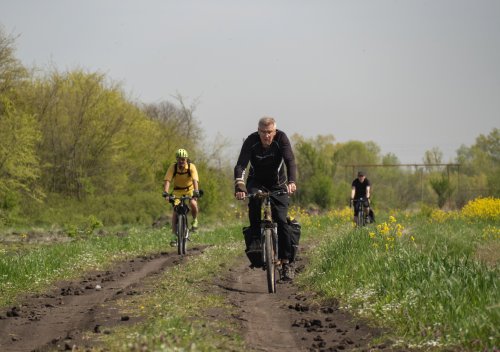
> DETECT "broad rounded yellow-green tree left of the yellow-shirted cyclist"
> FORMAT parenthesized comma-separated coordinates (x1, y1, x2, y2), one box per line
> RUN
(31, 70, 135, 198)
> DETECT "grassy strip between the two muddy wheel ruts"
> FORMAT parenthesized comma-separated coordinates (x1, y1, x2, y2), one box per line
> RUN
(104, 226, 245, 351)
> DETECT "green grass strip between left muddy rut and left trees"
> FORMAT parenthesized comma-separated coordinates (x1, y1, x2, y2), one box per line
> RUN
(0, 228, 176, 306)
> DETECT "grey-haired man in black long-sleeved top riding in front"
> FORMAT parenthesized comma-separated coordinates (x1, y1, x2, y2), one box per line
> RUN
(234, 117, 297, 279)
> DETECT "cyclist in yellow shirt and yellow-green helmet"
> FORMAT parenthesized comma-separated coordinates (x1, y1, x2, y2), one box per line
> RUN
(163, 149, 200, 243)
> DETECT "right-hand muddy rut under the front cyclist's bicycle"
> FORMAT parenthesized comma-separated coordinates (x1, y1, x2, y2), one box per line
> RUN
(216, 261, 398, 352)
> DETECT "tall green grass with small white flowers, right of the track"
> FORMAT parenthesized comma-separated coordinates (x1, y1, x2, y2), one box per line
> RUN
(302, 213, 500, 350)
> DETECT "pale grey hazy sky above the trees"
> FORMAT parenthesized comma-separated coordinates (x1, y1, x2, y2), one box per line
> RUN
(0, 0, 500, 163)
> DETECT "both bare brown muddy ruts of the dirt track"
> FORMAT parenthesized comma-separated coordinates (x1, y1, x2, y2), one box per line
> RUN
(0, 248, 393, 351)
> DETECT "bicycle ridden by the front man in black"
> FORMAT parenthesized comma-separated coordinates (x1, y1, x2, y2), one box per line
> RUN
(247, 190, 288, 293)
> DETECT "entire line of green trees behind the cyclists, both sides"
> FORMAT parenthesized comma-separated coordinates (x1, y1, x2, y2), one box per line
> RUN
(0, 30, 500, 226)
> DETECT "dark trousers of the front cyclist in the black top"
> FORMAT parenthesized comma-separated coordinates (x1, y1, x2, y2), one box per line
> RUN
(248, 188, 292, 259)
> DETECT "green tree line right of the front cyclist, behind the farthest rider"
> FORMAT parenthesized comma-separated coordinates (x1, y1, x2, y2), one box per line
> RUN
(292, 133, 500, 210)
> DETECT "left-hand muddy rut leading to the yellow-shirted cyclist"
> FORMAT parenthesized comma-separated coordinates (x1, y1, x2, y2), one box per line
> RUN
(0, 248, 205, 351)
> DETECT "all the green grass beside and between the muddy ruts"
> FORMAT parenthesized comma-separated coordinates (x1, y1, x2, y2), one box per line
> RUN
(0, 200, 500, 351)
